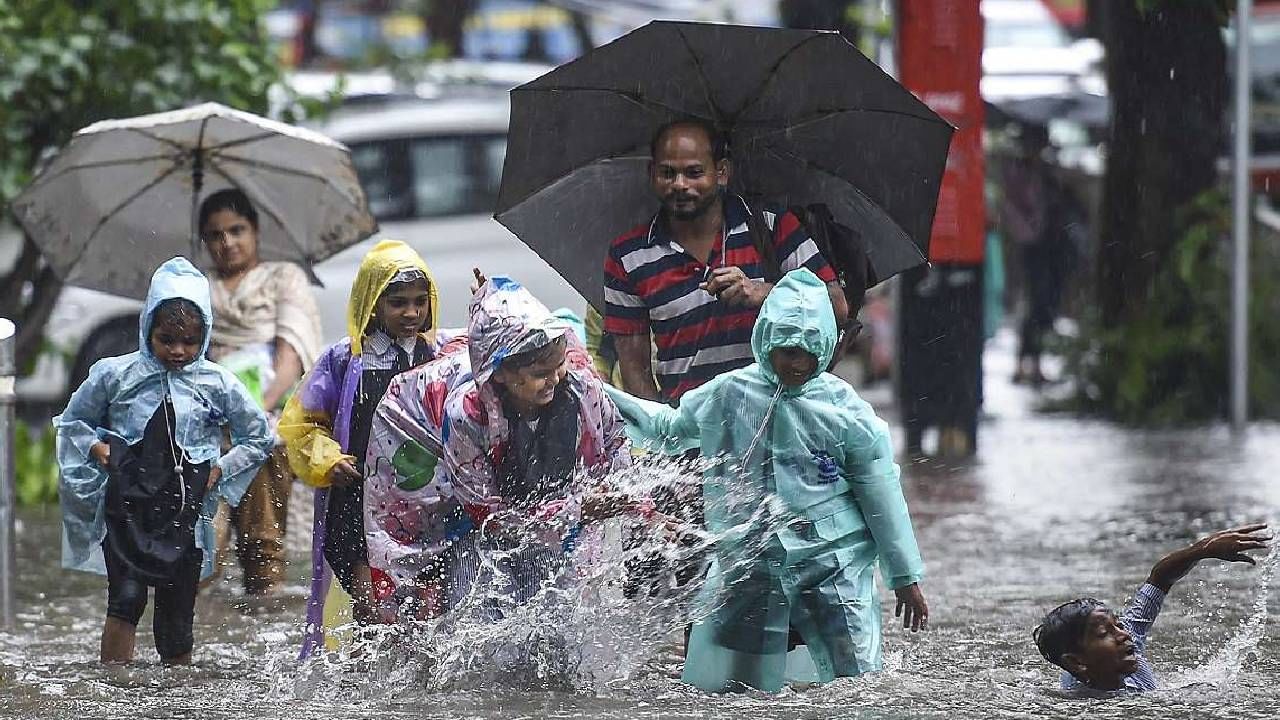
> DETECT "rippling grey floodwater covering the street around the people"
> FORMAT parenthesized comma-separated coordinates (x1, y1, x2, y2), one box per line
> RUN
(0, 338, 1280, 720)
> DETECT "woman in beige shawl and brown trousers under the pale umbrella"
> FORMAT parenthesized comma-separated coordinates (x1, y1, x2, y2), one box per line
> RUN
(198, 188, 320, 596)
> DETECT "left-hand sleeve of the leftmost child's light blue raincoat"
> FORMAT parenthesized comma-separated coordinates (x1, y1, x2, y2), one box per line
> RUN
(54, 359, 111, 562)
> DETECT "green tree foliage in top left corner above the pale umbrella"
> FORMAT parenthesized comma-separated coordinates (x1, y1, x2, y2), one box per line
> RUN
(0, 0, 304, 361)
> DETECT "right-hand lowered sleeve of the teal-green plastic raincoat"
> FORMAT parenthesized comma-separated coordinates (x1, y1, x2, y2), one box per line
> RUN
(844, 416, 924, 589)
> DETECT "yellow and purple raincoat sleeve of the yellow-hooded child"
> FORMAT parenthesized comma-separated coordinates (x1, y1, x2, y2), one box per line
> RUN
(275, 352, 356, 488)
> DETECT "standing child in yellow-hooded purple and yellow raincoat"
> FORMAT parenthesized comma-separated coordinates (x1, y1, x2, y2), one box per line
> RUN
(279, 240, 439, 656)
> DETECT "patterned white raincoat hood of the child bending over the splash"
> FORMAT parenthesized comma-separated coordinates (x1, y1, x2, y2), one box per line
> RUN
(467, 275, 568, 384)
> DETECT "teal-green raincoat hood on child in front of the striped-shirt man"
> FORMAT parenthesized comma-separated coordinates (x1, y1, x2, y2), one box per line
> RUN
(751, 268, 840, 383)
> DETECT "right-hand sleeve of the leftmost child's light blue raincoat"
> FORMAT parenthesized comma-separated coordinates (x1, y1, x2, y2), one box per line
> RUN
(212, 368, 275, 506)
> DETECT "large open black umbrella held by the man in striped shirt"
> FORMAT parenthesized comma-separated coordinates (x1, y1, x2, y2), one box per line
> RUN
(494, 22, 954, 307)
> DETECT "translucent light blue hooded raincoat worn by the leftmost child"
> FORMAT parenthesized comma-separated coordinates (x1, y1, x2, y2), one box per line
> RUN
(54, 258, 274, 577)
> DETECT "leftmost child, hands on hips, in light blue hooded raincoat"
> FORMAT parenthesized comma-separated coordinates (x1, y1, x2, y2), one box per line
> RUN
(54, 258, 273, 664)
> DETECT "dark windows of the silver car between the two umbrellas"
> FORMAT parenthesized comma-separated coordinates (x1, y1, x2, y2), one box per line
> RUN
(351, 135, 507, 215)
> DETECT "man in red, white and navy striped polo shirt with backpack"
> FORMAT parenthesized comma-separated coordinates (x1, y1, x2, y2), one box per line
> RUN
(604, 119, 849, 404)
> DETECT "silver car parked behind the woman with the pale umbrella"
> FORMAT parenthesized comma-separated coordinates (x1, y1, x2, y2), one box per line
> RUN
(18, 92, 586, 405)
